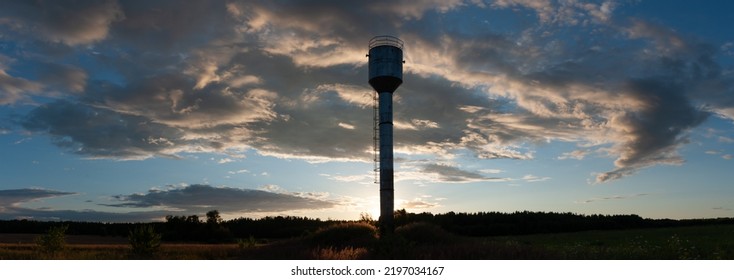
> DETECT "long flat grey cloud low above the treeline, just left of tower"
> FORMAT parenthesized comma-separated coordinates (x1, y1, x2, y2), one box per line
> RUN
(105, 185, 336, 213)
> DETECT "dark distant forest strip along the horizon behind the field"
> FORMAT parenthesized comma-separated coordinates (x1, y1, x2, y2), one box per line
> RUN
(0, 210, 734, 243)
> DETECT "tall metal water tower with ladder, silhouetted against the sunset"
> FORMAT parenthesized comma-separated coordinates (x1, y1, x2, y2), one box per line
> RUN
(367, 36, 405, 234)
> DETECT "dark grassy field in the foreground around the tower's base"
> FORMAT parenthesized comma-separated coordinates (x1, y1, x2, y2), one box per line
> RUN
(0, 223, 734, 260)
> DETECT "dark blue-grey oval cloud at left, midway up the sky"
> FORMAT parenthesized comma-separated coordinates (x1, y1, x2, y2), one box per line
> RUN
(23, 100, 194, 159)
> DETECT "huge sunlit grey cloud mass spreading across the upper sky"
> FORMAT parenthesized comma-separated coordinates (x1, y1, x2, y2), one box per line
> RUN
(5, 0, 734, 185)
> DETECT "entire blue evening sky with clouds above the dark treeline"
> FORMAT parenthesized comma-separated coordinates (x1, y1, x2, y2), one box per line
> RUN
(0, 0, 734, 222)
